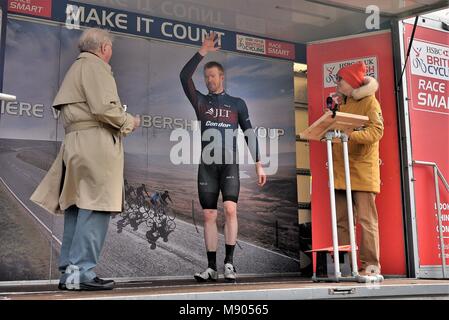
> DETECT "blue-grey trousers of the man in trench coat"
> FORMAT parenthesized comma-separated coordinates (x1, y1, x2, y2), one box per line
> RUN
(59, 206, 111, 283)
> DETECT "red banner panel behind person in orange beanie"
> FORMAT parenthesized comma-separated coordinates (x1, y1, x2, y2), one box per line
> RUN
(307, 32, 405, 275)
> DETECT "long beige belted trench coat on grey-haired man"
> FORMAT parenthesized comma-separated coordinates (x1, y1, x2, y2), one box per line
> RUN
(31, 52, 134, 213)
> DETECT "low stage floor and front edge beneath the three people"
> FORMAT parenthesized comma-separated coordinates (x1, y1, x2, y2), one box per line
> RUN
(0, 276, 449, 301)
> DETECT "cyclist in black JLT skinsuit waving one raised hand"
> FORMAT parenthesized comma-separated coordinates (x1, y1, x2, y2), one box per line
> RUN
(180, 33, 266, 281)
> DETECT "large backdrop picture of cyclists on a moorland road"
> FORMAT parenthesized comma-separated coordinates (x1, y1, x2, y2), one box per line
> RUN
(0, 18, 299, 281)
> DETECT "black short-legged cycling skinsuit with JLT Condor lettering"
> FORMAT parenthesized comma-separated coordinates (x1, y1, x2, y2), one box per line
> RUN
(180, 53, 259, 209)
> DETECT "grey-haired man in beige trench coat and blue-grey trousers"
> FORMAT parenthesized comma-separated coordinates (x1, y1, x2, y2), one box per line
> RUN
(31, 28, 140, 290)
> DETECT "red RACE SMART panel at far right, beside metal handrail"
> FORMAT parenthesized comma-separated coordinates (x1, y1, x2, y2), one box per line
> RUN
(404, 24, 449, 267)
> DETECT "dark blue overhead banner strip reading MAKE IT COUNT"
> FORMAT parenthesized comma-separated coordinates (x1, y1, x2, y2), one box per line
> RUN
(8, 0, 305, 63)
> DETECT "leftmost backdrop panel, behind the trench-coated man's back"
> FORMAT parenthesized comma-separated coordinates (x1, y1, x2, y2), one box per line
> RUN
(0, 19, 60, 281)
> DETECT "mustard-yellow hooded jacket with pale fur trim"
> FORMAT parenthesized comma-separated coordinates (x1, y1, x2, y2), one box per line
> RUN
(332, 77, 384, 193)
